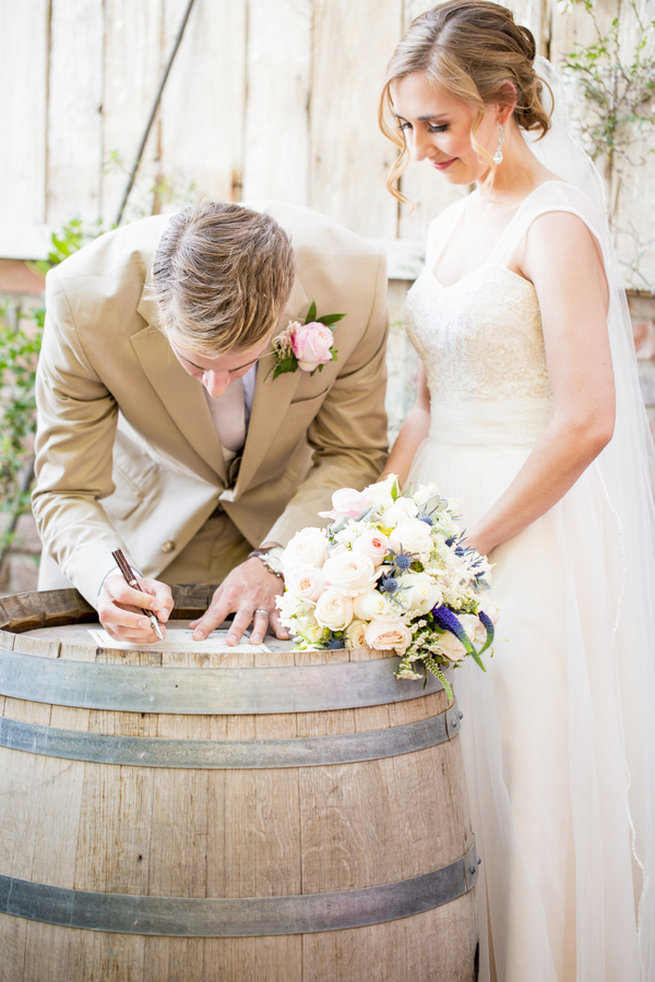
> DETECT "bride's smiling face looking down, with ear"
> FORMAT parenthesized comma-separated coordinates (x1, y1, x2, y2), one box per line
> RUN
(391, 72, 498, 184)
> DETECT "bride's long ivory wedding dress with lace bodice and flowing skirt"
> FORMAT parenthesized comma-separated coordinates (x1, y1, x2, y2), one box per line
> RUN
(406, 181, 655, 982)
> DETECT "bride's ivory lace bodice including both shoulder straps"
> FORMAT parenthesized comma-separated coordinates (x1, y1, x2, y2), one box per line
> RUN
(405, 180, 597, 421)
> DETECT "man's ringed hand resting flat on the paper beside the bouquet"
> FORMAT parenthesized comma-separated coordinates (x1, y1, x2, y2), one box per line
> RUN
(189, 558, 289, 645)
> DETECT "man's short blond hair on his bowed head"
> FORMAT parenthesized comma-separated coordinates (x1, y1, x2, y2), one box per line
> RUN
(151, 201, 295, 356)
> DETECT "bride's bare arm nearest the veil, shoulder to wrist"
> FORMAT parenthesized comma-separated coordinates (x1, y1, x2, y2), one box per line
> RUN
(467, 212, 615, 555)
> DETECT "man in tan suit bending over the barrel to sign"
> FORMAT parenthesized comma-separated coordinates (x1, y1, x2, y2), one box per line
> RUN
(33, 202, 387, 643)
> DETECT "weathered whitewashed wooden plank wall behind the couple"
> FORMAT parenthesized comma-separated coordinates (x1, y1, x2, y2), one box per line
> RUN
(0, 0, 655, 289)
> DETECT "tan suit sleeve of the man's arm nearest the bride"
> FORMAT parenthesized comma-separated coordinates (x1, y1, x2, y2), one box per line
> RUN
(265, 250, 388, 544)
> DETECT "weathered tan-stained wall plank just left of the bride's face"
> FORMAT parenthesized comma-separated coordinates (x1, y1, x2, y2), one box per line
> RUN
(308, 0, 400, 236)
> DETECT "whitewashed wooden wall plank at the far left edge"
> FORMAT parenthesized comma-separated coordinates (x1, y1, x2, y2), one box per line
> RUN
(0, 0, 48, 257)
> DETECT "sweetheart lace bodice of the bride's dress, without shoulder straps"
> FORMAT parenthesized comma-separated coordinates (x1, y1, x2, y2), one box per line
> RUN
(405, 263, 550, 404)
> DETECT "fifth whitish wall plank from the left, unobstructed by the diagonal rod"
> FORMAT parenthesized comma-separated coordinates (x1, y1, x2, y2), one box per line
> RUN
(243, 0, 312, 204)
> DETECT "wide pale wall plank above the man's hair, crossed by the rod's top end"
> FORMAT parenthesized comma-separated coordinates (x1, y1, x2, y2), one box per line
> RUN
(160, 0, 247, 207)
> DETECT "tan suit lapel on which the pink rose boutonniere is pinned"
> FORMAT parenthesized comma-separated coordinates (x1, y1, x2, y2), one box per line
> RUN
(234, 278, 310, 497)
